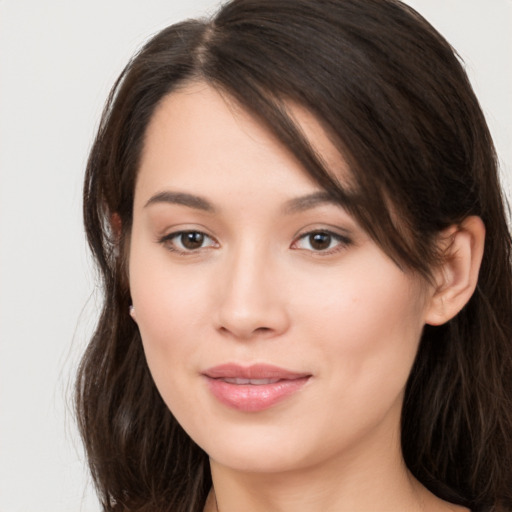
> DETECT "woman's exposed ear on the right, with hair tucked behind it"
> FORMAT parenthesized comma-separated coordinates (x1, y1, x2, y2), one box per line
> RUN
(425, 216, 485, 325)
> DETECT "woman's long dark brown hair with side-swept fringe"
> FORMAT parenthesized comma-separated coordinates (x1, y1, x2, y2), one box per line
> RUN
(76, 0, 512, 512)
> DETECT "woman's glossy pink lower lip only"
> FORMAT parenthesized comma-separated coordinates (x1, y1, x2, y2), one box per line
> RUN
(206, 376, 309, 412)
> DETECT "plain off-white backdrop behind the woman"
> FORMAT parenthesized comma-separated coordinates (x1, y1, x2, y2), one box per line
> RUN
(0, 0, 512, 512)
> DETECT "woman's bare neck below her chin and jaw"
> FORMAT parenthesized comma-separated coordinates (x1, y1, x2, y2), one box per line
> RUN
(205, 428, 434, 512)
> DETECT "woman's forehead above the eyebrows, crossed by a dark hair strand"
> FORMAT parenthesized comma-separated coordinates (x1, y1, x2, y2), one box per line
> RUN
(137, 83, 348, 202)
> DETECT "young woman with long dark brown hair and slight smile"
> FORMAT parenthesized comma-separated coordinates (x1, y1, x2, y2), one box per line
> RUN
(77, 0, 512, 512)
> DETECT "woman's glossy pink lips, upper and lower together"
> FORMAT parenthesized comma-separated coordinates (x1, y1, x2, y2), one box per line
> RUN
(203, 363, 311, 412)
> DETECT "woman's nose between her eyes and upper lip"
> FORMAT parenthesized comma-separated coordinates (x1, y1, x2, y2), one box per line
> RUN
(216, 244, 290, 340)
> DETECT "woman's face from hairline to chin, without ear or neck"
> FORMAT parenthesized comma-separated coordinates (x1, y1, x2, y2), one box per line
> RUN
(129, 84, 429, 472)
